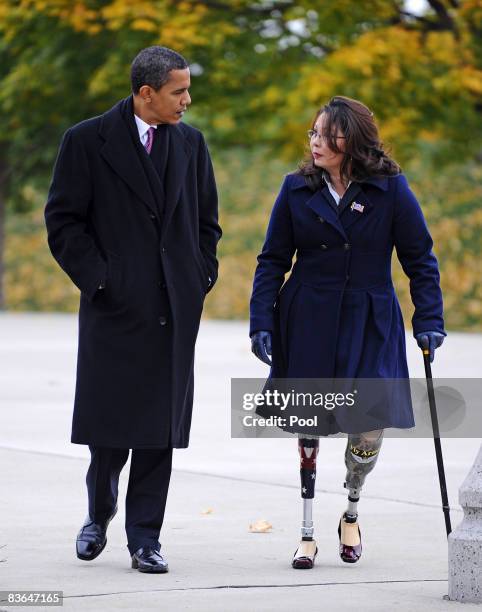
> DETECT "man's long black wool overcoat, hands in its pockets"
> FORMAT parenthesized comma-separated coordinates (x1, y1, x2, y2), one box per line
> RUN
(45, 96, 221, 448)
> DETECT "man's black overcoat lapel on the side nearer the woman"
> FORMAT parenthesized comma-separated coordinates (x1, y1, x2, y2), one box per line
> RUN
(161, 125, 192, 239)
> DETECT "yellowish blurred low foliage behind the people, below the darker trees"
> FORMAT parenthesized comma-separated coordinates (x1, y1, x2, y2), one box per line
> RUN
(5, 152, 482, 330)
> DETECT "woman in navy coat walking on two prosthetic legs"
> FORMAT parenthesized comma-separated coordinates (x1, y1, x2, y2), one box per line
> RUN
(250, 96, 446, 568)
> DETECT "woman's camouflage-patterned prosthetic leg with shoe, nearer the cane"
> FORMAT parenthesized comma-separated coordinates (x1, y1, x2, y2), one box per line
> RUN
(338, 429, 383, 563)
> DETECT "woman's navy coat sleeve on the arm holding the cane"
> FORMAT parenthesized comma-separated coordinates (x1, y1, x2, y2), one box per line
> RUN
(393, 174, 446, 336)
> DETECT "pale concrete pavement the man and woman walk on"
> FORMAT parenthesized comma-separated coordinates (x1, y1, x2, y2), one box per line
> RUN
(0, 314, 482, 612)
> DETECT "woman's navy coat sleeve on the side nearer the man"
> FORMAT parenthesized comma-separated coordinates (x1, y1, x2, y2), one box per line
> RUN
(249, 176, 295, 335)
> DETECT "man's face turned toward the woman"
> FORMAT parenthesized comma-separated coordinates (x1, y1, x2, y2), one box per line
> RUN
(139, 68, 191, 124)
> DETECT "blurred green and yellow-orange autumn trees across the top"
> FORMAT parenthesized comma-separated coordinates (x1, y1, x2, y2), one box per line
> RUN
(0, 0, 482, 307)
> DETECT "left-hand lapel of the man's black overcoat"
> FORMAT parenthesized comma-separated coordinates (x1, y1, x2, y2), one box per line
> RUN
(99, 98, 157, 214)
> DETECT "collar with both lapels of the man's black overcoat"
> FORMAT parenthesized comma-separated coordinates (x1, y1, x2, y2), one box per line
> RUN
(99, 95, 192, 234)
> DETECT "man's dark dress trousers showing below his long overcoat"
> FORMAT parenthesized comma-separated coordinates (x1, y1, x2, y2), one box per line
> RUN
(86, 446, 172, 555)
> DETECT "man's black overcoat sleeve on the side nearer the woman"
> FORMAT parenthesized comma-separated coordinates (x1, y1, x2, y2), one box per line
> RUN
(197, 136, 222, 292)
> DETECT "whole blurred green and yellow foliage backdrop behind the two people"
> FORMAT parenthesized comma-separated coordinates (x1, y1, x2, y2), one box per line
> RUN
(0, 0, 482, 330)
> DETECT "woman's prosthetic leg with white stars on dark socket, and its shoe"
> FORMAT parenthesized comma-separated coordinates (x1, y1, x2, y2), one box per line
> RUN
(291, 437, 319, 569)
